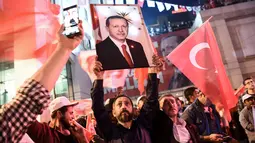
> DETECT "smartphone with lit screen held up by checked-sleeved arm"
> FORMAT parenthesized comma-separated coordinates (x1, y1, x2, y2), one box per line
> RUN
(63, 5, 81, 38)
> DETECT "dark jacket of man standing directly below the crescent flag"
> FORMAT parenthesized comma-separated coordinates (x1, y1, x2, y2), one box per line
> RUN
(181, 99, 222, 136)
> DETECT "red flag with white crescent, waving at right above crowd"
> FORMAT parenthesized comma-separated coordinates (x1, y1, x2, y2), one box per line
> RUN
(167, 20, 237, 121)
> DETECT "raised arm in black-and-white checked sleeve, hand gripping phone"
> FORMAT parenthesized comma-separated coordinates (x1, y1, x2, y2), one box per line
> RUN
(0, 23, 84, 143)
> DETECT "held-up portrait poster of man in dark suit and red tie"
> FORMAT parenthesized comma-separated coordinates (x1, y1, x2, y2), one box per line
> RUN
(91, 4, 153, 70)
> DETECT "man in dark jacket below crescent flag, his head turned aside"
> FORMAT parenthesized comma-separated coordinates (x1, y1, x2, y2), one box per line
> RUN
(181, 92, 237, 142)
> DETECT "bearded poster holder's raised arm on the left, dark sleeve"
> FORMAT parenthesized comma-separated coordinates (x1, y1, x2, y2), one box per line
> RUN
(91, 59, 112, 140)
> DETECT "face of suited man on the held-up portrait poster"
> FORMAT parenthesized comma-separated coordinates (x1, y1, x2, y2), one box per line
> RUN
(106, 18, 128, 43)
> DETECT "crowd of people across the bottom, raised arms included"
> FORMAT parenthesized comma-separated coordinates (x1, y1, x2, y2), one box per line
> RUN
(0, 21, 255, 143)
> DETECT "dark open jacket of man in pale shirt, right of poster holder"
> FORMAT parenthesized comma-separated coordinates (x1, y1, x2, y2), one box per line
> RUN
(151, 110, 199, 143)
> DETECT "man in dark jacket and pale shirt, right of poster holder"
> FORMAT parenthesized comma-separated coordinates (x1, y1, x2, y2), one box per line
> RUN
(151, 94, 199, 143)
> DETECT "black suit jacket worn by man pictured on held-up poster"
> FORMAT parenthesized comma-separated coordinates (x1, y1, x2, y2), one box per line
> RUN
(96, 37, 149, 70)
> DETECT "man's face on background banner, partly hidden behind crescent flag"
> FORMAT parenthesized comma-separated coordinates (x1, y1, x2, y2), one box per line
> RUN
(160, 36, 179, 65)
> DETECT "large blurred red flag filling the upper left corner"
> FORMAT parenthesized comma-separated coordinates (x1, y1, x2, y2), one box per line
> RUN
(0, 0, 60, 61)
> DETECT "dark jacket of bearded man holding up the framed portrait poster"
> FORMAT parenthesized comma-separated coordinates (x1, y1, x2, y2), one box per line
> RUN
(91, 74, 158, 143)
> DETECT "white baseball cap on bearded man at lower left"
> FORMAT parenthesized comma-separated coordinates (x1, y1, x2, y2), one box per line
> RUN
(49, 96, 79, 114)
